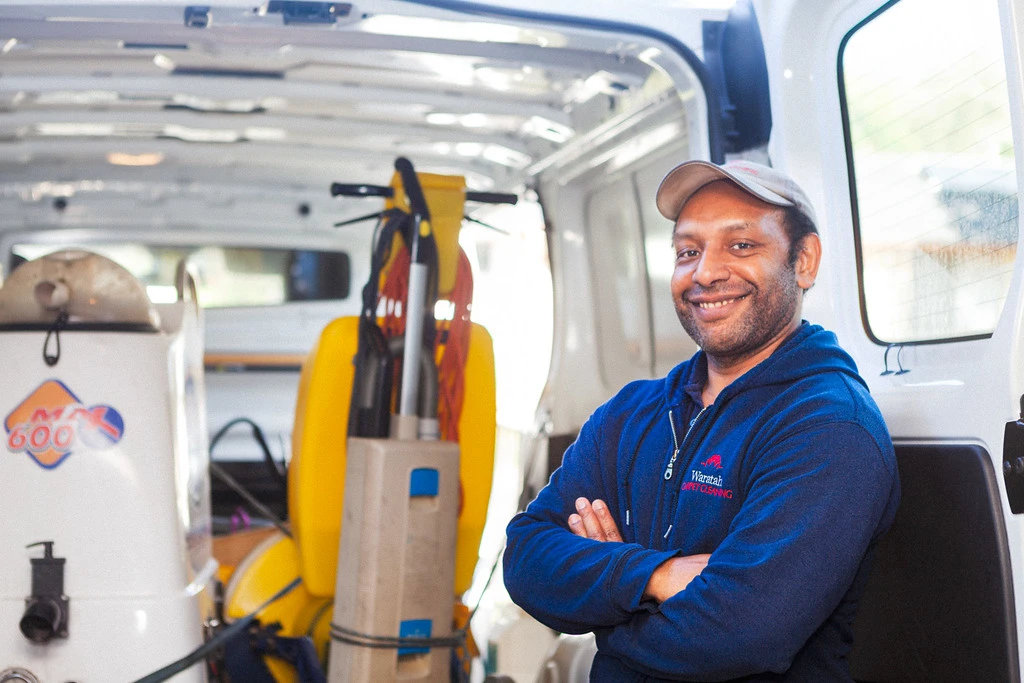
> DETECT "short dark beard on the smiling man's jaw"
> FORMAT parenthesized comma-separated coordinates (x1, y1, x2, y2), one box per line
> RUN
(676, 266, 803, 361)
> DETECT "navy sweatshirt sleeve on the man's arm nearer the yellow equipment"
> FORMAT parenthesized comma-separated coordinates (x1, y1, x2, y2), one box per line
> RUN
(504, 405, 678, 633)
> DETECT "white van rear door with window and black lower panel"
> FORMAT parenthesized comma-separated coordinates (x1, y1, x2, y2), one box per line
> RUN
(758, 0, 1024, 681)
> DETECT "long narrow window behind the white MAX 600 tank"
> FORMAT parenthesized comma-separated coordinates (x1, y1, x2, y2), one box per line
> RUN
(11, 244, 350, 307)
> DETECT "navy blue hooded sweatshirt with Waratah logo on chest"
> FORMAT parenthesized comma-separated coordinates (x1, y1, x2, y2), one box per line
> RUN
(504, 323, 899, 682)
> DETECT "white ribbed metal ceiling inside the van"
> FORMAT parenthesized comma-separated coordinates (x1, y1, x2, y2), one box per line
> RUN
(0, 1, 724, 240)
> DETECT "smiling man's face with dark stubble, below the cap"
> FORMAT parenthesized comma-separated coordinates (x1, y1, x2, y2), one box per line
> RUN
(671, 180, 817, 362)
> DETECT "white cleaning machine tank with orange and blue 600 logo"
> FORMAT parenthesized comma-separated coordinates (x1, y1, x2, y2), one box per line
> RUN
(0, 252, 216, 683)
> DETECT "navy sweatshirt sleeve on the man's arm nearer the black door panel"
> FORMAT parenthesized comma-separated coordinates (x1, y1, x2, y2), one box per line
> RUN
(598, 423, 899, 680)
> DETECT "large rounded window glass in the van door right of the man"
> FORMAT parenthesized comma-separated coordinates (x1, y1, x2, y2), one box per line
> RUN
(839, 0, 1018, 343)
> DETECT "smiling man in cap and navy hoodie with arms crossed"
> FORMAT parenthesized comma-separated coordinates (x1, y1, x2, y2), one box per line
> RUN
(505, 162, 899, 681)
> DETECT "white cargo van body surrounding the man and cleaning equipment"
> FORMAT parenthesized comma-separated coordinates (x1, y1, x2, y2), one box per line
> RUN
(0, 0, 1024, 681)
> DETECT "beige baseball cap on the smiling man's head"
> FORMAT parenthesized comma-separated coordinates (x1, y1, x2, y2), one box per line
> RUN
(655, 161, 818, 226)
